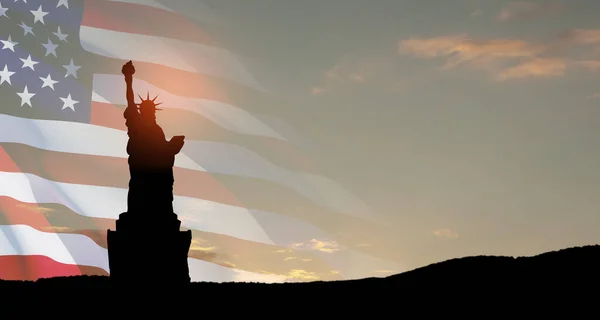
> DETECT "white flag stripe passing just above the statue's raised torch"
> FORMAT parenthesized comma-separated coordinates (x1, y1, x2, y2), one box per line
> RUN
(79, 26, 265, 92)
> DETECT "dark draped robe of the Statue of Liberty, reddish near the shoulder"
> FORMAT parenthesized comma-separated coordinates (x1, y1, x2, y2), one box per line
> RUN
(124, 108, 175, 213)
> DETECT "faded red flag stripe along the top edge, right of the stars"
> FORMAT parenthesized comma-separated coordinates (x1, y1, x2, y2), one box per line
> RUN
(81, 0, 217, 46)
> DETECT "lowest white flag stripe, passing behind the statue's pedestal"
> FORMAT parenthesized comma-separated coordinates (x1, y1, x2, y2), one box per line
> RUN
(0, 225, 282, 282)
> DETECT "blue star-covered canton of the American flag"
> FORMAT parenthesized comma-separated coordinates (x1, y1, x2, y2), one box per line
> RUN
(0, 0, 92, 122)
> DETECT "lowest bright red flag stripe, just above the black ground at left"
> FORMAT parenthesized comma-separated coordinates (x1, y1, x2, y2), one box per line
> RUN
(0, 255, 108, 281)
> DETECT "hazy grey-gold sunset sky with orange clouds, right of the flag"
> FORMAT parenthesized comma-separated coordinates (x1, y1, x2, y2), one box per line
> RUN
(196, 0, 600, 274)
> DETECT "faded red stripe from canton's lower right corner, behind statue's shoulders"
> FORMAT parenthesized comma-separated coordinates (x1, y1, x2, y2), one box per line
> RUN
(90, 102, 318, 173)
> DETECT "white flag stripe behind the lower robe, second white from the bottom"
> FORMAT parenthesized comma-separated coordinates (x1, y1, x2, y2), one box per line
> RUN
(0, 172, 274, 244)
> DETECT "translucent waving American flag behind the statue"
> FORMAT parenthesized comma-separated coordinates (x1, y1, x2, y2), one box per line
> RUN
(0, 0, 398, 282)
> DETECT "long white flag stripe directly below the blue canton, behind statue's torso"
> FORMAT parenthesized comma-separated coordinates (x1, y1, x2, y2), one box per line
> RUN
(0, 115, 378, 222)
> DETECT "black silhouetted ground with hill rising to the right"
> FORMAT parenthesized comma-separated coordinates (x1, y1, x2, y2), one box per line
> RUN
(0, 245, 600, 312)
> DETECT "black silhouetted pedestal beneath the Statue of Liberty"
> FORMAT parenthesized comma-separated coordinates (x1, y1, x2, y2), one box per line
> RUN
(107, 212, 192, 285)
